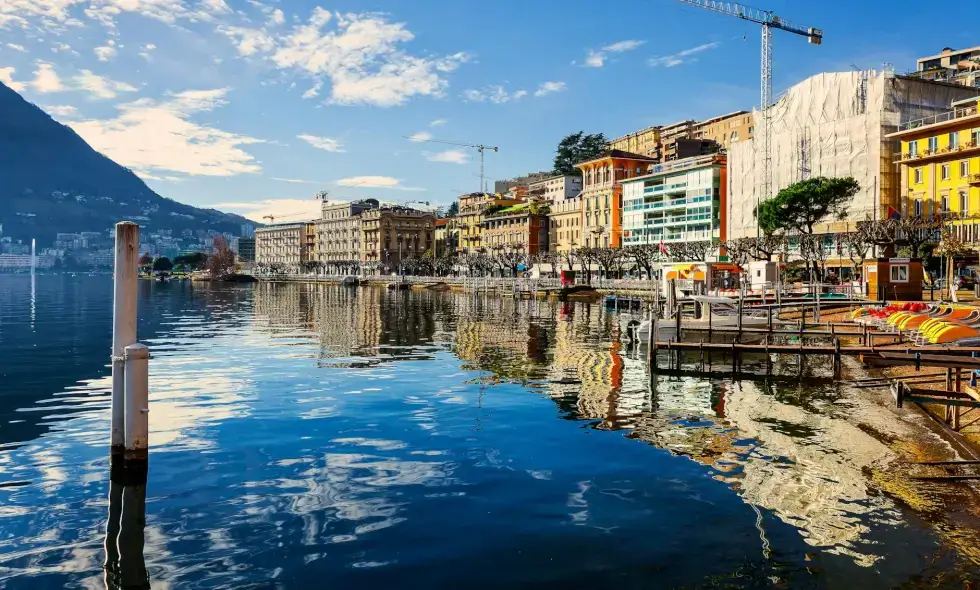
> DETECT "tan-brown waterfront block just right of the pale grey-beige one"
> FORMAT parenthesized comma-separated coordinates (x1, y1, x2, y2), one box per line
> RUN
(361, 207, 436, 270)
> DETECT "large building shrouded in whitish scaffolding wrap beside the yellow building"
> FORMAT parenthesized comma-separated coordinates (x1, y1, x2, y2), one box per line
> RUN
(727, 70, 980, 238)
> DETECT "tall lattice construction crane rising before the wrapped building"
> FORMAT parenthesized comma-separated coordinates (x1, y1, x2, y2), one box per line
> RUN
(677, 0, 823, 232)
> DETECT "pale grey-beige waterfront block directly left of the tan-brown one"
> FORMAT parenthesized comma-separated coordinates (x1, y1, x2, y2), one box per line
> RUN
(314, 199, 378, 271)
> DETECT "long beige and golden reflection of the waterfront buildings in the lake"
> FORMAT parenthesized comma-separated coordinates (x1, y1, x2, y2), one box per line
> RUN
(245, 284, 920, 566)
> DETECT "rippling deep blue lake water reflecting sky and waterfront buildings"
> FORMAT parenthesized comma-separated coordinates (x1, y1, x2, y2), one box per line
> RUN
(0, 276, 972, 589)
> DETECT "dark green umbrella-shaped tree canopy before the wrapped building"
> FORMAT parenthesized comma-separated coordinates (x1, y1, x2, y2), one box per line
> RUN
(759, 176, 861, 234)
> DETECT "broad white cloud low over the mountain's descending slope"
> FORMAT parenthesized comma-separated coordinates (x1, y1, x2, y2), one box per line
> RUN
(69, 88, 262, 176)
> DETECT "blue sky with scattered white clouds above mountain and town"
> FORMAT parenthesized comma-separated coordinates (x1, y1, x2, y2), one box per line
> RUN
(0, 0, 968, 219)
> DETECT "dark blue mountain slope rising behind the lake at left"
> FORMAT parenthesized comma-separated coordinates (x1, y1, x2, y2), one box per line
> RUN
(0, 83, 259, 245)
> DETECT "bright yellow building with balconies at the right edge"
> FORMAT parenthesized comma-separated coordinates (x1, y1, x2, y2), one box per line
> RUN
(888, 98, 980, 241)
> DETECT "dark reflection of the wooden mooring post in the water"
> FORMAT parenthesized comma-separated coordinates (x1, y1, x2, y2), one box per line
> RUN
(103, 457, 150, 590)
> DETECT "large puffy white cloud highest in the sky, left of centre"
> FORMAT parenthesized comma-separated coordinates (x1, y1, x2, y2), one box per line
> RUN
(221, 6, 469, 107)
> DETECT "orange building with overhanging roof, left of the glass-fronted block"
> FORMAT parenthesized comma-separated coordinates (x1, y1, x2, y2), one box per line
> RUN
(575, 150, 655, 248)
